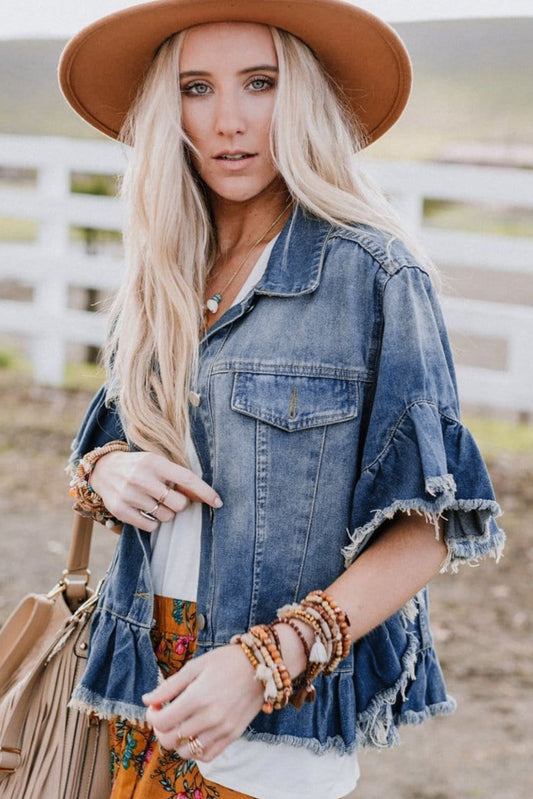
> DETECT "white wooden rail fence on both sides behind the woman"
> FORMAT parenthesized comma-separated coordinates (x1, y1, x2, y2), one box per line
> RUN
(0, 136, 533, 415)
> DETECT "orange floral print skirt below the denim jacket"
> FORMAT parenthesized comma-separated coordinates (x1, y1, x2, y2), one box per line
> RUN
(109, 596, 252, 799)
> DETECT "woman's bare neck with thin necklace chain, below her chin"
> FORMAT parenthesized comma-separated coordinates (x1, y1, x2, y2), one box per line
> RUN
(211, 186, 289, 259)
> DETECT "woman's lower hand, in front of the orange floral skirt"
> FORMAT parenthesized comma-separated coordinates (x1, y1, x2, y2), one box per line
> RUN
(143, 644, 263, 762)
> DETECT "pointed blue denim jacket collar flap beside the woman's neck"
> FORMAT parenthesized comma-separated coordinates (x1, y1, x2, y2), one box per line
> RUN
(255, 205, 331, 297)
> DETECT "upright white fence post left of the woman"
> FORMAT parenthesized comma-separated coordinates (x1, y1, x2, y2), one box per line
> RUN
(31, 158, 70, 386)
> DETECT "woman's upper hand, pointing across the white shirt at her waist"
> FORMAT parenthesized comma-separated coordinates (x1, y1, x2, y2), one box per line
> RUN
(90, 452, 222, 533)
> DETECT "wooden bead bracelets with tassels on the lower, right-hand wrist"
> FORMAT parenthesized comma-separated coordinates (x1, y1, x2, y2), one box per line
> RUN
(231, 591, 351, 713)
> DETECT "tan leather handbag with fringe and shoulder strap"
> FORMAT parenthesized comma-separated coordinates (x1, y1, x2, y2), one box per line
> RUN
(0, 515, 111, 799)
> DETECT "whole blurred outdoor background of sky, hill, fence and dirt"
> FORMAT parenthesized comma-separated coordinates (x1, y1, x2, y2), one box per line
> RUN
(0, 0, 533, 799)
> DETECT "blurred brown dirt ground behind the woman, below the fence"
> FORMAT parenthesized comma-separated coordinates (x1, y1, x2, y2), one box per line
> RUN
(0, 372, 533, 799)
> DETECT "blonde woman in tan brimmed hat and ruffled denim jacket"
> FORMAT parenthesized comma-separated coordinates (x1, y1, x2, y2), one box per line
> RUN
(60, 0, 503, 799)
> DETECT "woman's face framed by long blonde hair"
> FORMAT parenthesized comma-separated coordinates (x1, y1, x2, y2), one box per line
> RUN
(180, 22, 279, 202)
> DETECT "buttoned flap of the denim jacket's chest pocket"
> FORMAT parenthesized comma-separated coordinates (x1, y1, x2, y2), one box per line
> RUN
(231, 372, 358, 432)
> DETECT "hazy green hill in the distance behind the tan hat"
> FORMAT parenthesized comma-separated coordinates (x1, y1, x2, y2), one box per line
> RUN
(0, 18, 533, 157)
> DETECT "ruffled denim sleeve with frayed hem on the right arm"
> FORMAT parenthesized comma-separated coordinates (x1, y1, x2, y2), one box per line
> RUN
(343, 266, 505, 571)
